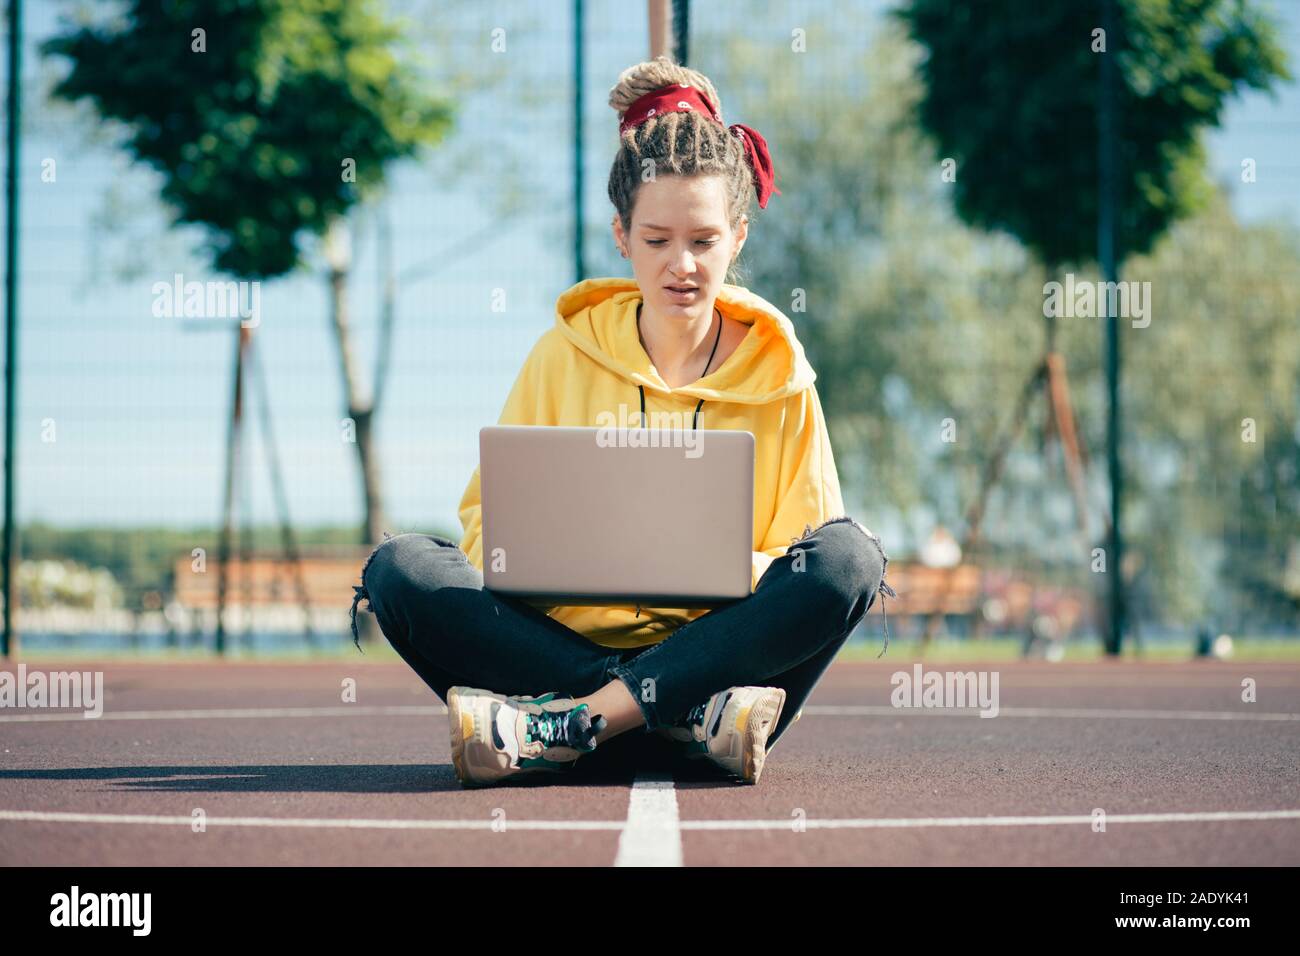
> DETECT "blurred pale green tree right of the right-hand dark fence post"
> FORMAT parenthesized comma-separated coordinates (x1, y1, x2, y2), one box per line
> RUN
(1125, 193, 1300, 630)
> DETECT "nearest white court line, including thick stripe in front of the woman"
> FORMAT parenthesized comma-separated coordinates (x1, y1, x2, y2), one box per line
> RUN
(0, 806, 1300, 832)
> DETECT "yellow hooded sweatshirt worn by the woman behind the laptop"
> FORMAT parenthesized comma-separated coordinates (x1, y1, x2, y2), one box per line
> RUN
(459, 278, 844, 648)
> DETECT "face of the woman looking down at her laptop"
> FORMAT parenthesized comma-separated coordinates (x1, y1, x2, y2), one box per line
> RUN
(614, 176, 749, 319)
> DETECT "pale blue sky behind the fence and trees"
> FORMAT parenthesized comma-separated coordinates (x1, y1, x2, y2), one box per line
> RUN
(2, 0, 1300, 548)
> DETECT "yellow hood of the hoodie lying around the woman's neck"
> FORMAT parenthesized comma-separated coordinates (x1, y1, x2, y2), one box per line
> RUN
(555, 278, 816, 405)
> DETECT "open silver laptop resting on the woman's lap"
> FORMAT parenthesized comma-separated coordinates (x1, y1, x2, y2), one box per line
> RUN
(478, 425, 754, 607)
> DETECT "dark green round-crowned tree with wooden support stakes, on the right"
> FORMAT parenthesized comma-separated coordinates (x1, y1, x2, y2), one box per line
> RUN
(897, 0, 1290, 642)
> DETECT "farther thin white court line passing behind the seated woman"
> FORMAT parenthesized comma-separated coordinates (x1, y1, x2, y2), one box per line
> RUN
(0, 704, 1300, 723)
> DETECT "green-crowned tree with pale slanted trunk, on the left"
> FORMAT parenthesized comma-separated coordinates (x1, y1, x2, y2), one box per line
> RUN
(44, 0, 452, 642)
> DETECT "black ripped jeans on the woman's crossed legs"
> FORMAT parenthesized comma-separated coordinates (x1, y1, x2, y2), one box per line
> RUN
(352, 516, 894, 747)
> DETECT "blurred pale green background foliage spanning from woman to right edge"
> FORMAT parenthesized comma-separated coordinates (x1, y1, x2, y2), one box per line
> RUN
(717, 9, 1300, 642)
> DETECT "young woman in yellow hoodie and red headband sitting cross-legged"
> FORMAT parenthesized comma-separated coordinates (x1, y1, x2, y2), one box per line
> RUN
(352, 57, 893, 786)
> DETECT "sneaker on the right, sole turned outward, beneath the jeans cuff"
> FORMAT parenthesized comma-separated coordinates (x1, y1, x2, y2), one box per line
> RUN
(657, 687, 785, 783)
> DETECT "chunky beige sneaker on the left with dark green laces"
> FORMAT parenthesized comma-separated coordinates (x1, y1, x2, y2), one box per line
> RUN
(447, 687, 606, 787)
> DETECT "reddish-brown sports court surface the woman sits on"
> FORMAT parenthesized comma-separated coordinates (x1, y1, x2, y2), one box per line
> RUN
(0, 658, 1300, 866)
